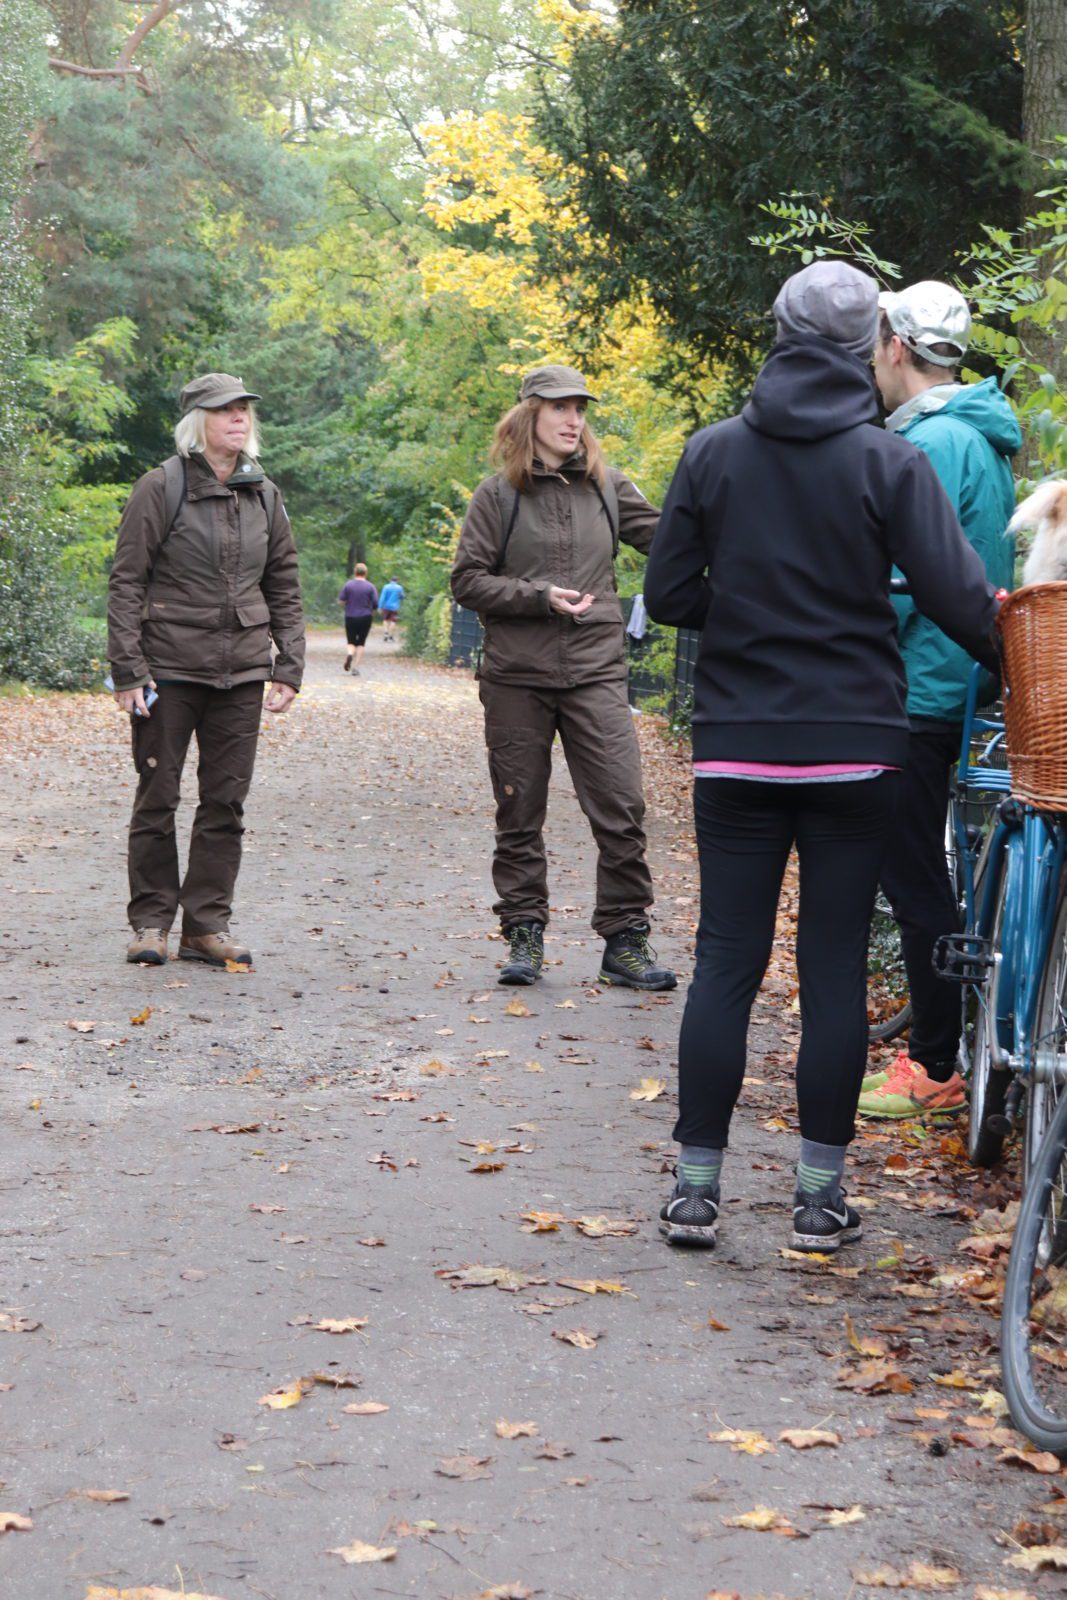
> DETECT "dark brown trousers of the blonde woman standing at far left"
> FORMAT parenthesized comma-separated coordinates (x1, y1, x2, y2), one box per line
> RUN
(128, 682, 264, 934)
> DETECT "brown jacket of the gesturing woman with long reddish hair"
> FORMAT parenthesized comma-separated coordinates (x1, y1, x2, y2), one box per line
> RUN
(451, 458, 659, 688)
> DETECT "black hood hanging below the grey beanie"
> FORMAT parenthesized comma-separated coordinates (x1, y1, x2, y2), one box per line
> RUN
(741, 334, 878, 440)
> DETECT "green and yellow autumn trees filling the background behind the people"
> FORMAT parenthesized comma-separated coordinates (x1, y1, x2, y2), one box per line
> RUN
(0, 0, 1067, 683)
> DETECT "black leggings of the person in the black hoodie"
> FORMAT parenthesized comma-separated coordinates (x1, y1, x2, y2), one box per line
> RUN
(675, 771, 901, 1150)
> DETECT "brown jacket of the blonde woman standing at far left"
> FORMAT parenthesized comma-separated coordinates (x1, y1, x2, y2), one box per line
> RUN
(107, 456, 304, 690)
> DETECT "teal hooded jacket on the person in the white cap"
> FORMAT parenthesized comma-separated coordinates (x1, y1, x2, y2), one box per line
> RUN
(891, 378, 1022, 722)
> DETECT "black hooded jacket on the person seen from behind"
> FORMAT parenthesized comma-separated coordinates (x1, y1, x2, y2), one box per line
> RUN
(645, 334, 997, 766)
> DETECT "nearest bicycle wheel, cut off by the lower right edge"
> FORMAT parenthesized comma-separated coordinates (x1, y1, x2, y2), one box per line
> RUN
(1000, 1094, 1067, 1458)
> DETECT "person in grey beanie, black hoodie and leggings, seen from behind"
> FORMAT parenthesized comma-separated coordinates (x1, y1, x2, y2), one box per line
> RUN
(645, 261, 997, 1251)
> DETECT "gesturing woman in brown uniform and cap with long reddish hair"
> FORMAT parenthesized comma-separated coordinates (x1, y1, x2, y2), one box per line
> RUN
(453, 366, 677, 989)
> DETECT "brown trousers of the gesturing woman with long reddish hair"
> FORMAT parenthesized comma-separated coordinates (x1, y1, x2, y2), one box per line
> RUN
(478, 678, 653, 938)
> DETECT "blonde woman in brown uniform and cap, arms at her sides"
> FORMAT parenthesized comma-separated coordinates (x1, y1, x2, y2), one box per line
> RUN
(107, 373, 304, 966)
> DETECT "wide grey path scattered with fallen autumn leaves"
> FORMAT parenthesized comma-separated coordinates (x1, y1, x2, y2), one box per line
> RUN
(0, 635, 1049, 1600)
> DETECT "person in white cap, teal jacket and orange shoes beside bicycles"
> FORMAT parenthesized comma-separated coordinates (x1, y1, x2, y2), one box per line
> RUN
(859, 282, 1022, 1117)
